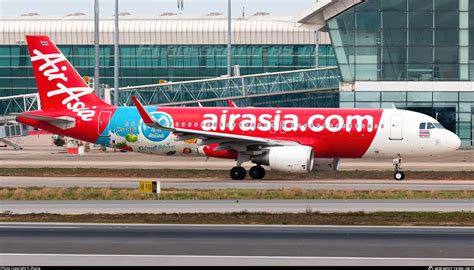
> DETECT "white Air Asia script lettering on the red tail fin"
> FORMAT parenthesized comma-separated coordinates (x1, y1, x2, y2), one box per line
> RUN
(31, 50, 97, 121)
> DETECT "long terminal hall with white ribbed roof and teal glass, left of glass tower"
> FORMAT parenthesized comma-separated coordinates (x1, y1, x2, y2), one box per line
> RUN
(0, 16, 337, 96)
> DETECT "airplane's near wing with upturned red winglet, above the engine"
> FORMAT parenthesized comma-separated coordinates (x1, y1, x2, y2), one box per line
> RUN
(132, 97, 300, 146)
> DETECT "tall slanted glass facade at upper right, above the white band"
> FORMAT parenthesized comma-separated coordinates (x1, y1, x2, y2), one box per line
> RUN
(328, 0, 474, 82)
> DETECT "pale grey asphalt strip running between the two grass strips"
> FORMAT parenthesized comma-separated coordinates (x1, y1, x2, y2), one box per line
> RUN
(0, 200, 474, 214)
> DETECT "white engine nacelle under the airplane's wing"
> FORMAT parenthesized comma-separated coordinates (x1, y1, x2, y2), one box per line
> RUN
(251, 146, 314, 173)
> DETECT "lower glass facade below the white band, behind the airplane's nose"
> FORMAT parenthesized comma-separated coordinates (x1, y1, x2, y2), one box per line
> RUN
(339, 91, 474, 146)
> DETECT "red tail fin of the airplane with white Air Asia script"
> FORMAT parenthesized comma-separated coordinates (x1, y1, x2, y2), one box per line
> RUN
(26, 36, 110, 121)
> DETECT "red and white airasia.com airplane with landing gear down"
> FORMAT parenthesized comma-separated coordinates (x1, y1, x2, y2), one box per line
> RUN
(17, 35, 461, 180)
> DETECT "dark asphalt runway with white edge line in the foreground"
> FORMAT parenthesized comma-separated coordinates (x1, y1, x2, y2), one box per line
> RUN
(0, 223, 474, 266)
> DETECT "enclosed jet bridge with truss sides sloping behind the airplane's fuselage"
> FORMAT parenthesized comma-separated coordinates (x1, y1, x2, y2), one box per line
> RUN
(105, 67, 340, 107)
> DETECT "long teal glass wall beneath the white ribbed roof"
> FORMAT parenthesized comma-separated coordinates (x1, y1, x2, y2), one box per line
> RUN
(0, 45, 336, 96)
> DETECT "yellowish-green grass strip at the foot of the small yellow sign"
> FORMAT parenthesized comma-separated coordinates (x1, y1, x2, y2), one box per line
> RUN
(0, 187, 474, 200)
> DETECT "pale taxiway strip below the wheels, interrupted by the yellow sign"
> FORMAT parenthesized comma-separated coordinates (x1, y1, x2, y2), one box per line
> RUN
(0, 176, 474, 191)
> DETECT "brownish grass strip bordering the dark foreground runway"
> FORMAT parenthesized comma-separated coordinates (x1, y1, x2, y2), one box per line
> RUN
(0, 212, 474, 226)
